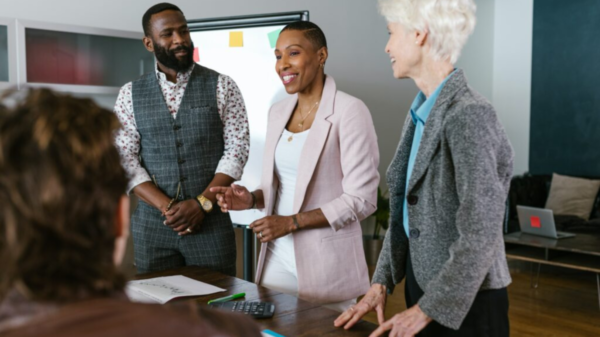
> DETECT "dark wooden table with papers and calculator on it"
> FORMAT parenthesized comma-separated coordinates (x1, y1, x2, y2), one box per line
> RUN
(136, 266, 387, 337)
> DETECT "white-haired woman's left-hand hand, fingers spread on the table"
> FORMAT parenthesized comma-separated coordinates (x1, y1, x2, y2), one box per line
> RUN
(333, 283, 387, 330)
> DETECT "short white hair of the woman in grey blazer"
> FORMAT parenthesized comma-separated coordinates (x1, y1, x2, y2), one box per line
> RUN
(379, 0, 476, 64)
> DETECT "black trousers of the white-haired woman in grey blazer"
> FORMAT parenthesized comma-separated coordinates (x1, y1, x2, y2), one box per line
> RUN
(404, 247, 509, 337)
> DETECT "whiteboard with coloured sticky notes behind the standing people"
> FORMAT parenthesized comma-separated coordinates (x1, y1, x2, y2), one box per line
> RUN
(191, 24, 288, 225)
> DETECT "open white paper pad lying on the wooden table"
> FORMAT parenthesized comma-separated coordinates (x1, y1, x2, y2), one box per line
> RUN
(125, 275, 225, 304)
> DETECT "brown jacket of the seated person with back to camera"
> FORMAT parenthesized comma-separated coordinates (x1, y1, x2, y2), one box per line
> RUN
(0, 298, 261, 337)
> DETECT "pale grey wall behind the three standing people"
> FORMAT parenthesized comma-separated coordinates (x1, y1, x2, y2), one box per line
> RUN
(0, 0, 516, 181)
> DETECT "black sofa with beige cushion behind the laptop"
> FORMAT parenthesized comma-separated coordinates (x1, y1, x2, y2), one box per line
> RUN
(504, 173, 600, 234)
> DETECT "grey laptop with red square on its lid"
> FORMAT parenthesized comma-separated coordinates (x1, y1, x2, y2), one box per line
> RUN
(517, 206, 575, 239)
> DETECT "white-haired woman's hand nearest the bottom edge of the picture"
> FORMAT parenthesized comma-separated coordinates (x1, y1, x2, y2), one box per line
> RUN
(369, 304, 432, 337)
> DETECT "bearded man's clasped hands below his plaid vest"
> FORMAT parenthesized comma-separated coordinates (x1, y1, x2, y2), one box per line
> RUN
(164, 199, 204, 235)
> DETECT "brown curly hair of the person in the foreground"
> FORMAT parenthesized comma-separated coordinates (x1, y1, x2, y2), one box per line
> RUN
(0, 89, 127, 302)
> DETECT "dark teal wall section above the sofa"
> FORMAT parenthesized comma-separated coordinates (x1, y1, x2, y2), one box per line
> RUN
(529, 0, 600, 178)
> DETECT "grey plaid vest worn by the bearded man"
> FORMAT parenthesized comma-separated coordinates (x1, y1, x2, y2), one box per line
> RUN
(132, 64, 224, 199)
